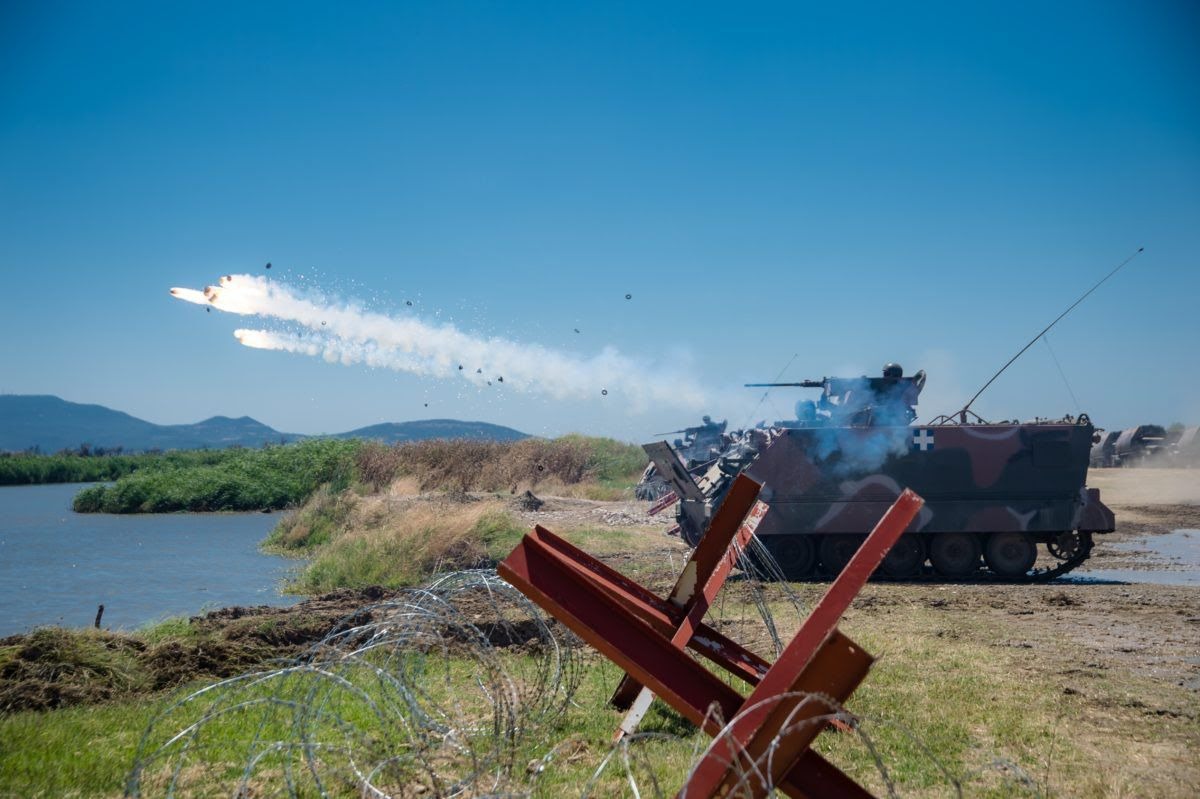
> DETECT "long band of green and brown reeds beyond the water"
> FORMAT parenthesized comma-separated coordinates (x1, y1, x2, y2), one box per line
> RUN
(60, 434, 646, 513)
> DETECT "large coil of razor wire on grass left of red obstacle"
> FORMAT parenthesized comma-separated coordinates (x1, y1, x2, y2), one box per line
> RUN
(126, 571, 582, 797)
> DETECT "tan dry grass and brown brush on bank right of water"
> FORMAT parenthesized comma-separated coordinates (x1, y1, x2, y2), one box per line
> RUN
(272, 435, 646, 593)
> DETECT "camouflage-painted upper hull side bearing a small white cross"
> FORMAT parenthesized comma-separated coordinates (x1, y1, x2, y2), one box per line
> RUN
(746, 425, 1112, 536)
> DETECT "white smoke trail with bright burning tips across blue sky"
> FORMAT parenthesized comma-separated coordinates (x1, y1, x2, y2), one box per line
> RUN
(170, 275, 709, 410)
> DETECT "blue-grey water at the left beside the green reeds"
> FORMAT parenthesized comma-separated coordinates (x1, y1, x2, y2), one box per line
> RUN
(0, 483, 299, 636)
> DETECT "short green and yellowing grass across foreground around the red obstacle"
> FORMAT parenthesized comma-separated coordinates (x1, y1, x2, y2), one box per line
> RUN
(0, 578, 1196, 797)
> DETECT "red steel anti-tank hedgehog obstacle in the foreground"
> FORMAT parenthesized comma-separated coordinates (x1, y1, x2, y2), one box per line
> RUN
(498, 486, 923, 799)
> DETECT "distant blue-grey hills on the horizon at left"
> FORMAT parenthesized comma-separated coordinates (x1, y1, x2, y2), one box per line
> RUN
(0, 394, 528, 452)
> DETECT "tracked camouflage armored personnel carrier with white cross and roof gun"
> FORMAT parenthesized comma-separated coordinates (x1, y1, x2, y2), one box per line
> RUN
(644, 364, 1115, 582)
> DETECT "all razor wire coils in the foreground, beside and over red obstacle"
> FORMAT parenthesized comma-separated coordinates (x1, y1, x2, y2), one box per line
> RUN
(126, 554, 1042, 799)
